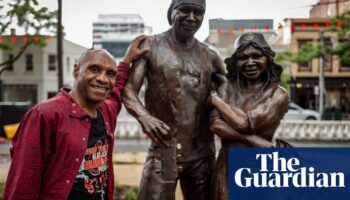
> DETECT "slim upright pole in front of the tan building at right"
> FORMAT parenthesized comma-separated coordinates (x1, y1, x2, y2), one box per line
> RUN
(318, 30, 325, 119)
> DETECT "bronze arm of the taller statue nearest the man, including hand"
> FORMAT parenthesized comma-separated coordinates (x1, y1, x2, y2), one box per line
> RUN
(123, 37, 170, 147)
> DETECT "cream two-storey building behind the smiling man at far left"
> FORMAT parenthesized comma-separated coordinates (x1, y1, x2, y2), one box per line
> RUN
(0, 35, 87, 105)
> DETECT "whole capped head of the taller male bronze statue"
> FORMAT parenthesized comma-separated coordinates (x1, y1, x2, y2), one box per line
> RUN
(167, 0, 206, 37)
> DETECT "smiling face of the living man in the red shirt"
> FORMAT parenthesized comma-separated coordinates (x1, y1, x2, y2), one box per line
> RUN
(73, 50, 117, 104)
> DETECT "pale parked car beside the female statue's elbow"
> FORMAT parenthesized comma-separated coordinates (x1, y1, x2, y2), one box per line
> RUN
(283, 103, 320, 120)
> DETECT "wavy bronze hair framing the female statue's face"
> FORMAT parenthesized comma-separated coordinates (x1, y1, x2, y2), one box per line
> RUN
(225, 42, 283, 83)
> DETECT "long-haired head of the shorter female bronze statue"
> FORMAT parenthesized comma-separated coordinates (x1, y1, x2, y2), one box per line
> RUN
(225, 32, 283, 82)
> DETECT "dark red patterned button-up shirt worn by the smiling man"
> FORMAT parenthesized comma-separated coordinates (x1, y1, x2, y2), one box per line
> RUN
(4, 63, 129, 200)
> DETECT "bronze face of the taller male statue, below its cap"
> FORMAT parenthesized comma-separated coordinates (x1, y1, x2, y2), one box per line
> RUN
(172, 3, 205, 37)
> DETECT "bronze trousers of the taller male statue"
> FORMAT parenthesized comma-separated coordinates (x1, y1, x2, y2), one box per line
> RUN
(137, 154, 215, 200)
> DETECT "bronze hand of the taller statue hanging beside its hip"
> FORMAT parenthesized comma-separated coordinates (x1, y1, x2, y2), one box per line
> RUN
(139, 115, 170, 147)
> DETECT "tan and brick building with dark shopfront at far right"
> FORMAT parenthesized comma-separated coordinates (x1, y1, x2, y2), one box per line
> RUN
(285, 18, 350, 118)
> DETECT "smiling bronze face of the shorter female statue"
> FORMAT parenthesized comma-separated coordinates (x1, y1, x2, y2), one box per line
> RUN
(236, 46, 267, 80)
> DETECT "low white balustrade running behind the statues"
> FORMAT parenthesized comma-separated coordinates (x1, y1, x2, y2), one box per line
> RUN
(116, 118, 350, 141)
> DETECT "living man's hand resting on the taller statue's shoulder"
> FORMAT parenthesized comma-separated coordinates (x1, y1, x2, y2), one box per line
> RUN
(123, 35, 149, 64)
